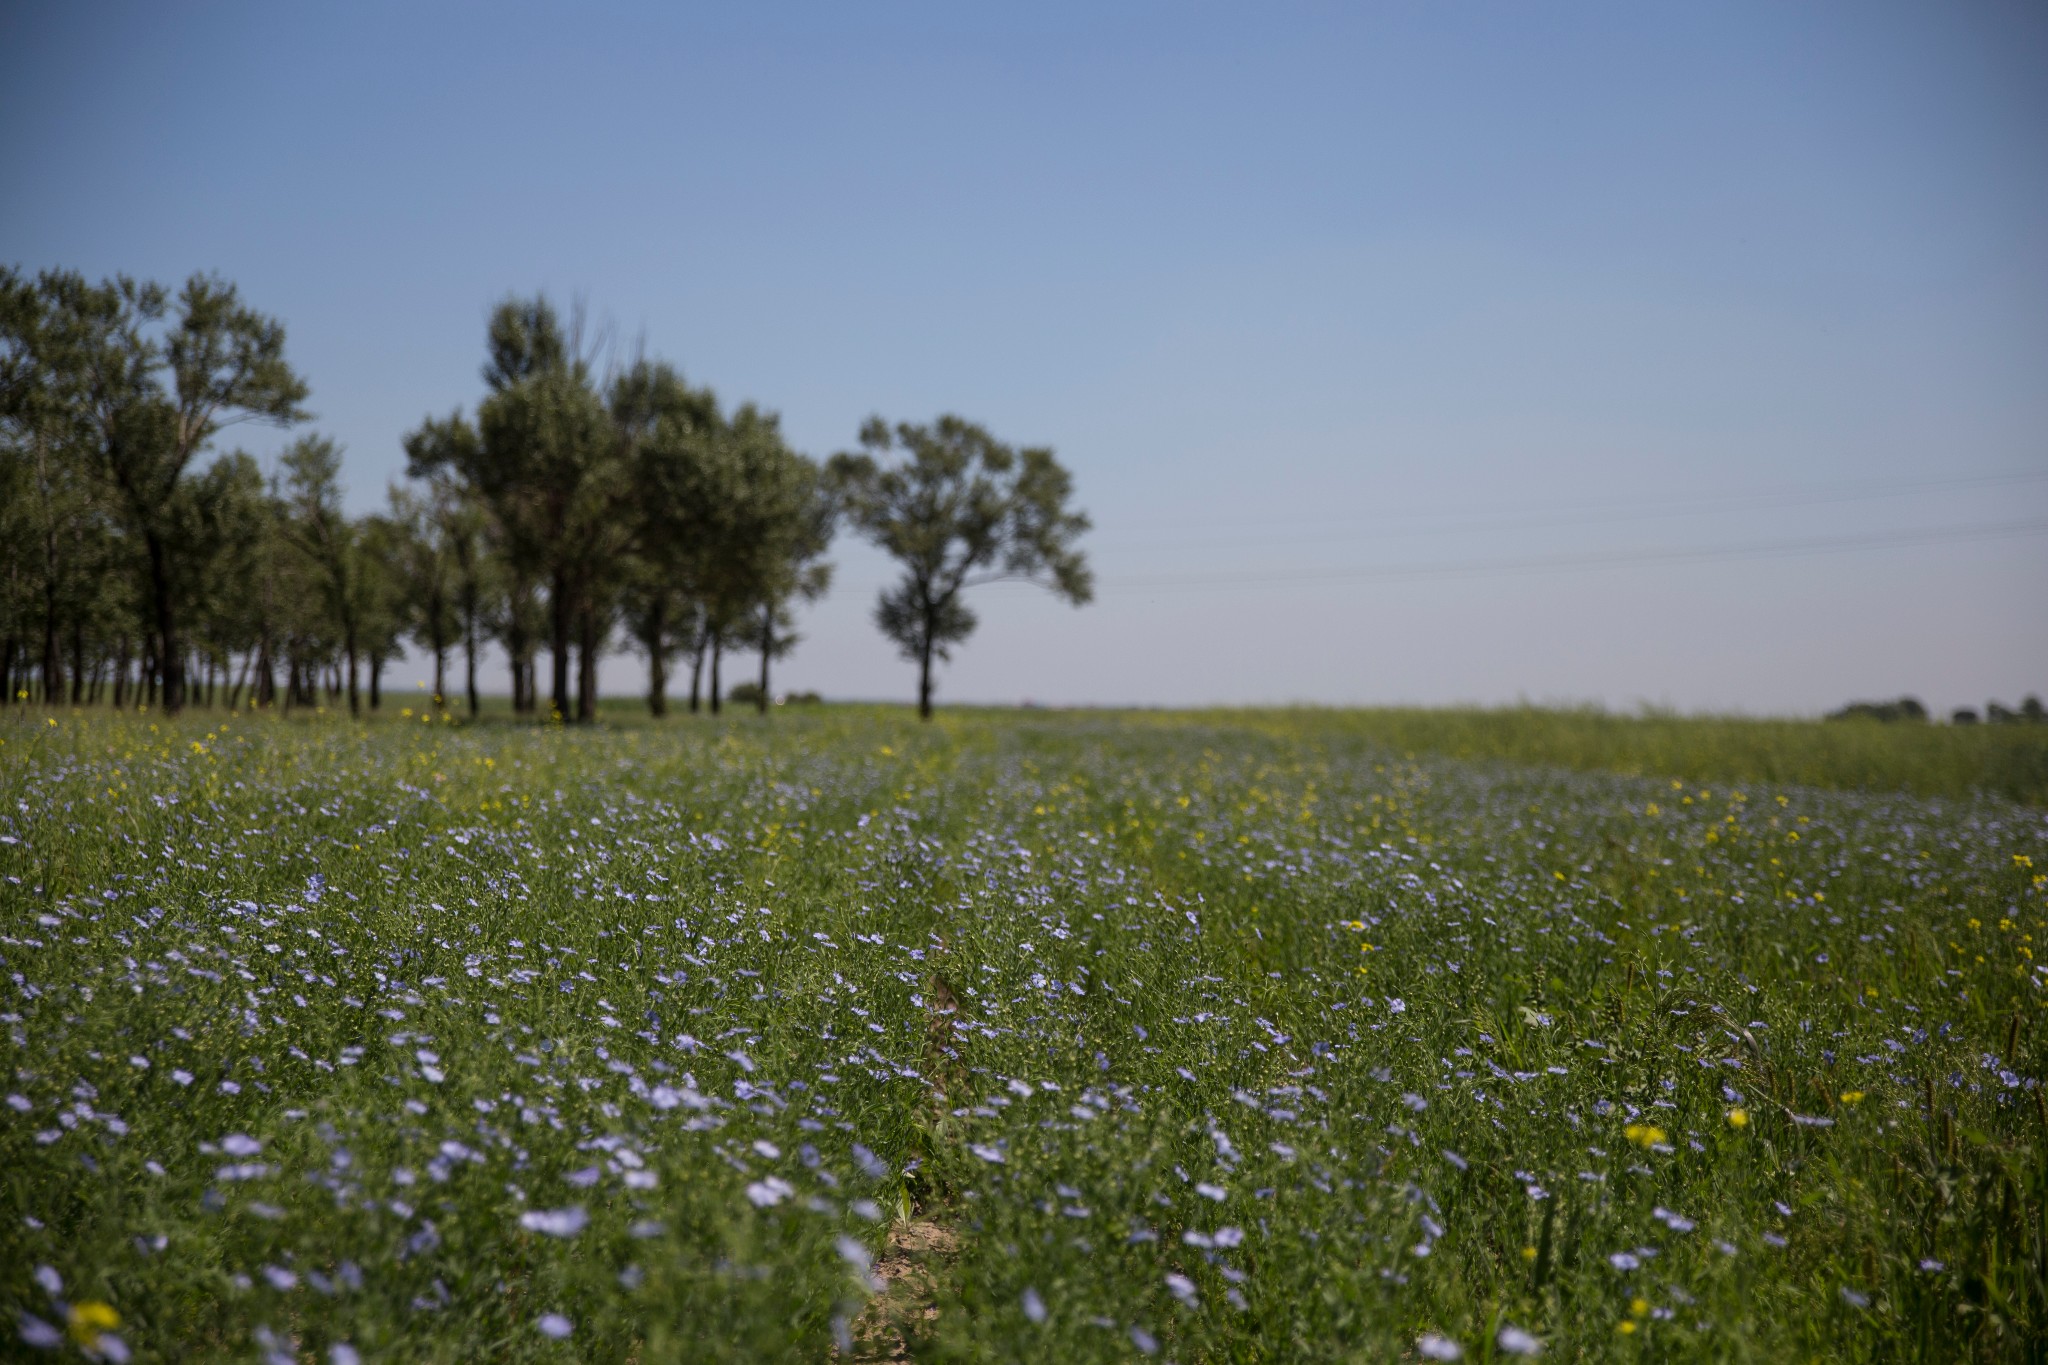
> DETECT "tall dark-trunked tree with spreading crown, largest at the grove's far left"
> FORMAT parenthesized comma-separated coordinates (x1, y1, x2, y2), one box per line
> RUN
(31, 272, 307, 710)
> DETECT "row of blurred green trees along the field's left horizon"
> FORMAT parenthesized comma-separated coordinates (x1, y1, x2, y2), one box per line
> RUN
(0, 268, 1092, 720)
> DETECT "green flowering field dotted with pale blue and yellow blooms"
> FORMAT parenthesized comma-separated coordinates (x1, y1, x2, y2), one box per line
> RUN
(0, 708, 2048, 1365)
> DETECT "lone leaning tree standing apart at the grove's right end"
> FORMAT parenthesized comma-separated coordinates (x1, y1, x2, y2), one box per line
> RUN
(827, 413, 1094, 720)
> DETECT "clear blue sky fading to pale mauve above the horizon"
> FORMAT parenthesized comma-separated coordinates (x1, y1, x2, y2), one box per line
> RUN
(0, 0, 2048, 712)
